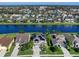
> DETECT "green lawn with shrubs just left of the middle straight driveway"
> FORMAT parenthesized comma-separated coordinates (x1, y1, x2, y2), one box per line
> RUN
(18, 40, 33, 55)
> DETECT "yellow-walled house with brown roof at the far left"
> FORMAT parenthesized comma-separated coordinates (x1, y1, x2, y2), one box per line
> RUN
(0, 36, 14, 51)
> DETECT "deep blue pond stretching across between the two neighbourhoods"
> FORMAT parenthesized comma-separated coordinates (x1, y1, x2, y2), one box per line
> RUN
(0, 25, 79, 33)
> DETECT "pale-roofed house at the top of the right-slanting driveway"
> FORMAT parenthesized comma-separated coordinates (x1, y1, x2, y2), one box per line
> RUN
(52, 34, 66, 47)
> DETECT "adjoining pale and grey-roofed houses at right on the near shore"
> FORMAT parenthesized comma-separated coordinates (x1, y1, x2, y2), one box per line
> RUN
(52, 34, 79, 48)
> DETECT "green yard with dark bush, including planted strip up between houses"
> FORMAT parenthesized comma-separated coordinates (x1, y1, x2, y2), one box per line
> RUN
(40, 33, 63, 55)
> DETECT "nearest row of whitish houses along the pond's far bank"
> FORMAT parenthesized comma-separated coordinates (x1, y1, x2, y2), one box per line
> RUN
(0, 14, 76, 22)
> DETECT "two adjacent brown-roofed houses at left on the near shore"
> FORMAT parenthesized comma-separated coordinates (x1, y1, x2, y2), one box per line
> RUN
(0, 33, 30, 51)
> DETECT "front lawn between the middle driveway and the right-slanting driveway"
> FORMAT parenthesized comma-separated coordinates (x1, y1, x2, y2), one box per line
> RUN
(40, 47, 63, 55)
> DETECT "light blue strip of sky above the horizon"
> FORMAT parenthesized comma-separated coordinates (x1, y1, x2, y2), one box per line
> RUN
(0, 2, 79, 6)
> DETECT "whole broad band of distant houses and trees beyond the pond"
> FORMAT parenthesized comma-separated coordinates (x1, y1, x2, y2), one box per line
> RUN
(0, 6, 79, 22)
